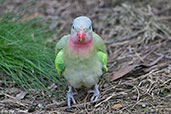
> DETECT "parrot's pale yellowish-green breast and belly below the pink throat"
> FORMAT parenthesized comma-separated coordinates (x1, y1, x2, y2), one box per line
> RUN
(63, 41, 102, 88)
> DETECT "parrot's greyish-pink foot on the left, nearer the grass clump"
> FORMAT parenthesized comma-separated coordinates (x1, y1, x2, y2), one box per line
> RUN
(67, 86, 77, 108)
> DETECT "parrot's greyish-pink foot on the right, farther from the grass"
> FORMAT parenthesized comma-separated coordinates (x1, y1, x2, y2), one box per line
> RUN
(88, 84, 100, 102)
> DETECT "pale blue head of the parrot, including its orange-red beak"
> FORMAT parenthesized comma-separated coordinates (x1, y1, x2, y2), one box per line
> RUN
(71, 16, 92, 41)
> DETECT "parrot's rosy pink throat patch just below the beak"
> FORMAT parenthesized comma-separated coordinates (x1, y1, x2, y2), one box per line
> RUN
(68, 34, 93, 55)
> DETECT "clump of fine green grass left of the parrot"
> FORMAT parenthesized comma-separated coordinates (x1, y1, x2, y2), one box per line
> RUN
(0, 18, 61, 91)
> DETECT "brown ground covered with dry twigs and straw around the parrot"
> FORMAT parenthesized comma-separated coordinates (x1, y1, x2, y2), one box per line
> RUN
(0, 0, 171, 114)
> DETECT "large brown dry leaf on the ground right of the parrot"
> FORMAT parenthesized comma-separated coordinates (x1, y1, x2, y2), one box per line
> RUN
(110, 64, 138, 81)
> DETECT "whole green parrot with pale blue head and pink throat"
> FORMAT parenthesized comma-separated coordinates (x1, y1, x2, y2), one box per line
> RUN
(55, 16, 108, 108)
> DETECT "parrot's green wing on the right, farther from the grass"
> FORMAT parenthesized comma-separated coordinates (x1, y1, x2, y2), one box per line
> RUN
(93, 32, 108, 72)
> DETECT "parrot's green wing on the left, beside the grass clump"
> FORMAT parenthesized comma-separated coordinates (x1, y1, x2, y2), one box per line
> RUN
(55, 35, 70, 76)
